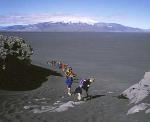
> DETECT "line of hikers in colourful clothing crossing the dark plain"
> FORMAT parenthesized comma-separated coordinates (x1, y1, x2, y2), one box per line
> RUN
(47, 60, 95, 101)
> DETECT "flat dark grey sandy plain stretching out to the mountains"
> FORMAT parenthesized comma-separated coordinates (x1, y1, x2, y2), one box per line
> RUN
(0, 33, 150, 122)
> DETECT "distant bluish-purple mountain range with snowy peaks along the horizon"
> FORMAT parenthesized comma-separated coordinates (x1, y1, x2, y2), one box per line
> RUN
(0, 22, 150, 32)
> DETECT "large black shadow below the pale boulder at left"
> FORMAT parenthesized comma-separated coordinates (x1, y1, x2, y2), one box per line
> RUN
(0, 57, 62, 91)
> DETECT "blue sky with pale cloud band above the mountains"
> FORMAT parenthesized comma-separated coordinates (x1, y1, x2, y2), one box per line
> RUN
(0, 0, 150, 29)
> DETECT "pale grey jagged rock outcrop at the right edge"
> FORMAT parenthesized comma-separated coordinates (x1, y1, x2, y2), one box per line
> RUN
(119, 72, 150, 114)
